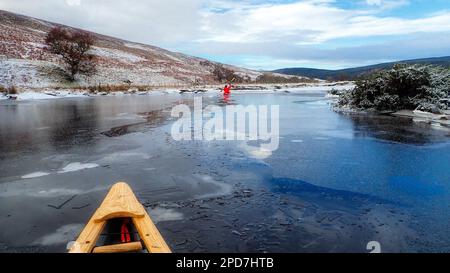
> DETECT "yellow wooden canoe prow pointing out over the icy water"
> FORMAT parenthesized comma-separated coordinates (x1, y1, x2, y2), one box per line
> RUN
(69, 182, 171, 253)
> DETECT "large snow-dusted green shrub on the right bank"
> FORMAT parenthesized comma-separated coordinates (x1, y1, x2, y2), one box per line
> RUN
(339, 65, 450, 112)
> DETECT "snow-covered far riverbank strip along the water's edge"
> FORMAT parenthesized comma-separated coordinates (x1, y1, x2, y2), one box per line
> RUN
(0, 82, 354, 101)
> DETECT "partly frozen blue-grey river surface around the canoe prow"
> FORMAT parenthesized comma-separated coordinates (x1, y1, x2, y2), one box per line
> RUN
(0, 92, 450, 252)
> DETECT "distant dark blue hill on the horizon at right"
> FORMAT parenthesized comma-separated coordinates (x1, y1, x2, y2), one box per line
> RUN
(273, 56, 450, 80)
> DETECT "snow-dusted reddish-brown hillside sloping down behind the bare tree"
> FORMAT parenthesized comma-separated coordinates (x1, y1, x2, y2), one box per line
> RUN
(0, 10, 310, 88)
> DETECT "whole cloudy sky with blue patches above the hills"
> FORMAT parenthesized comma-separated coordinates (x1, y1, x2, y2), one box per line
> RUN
(0, 0, 450, 69)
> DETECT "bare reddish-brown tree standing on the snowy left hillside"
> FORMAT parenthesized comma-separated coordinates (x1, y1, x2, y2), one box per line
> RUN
(45, 27, 96, 81)
